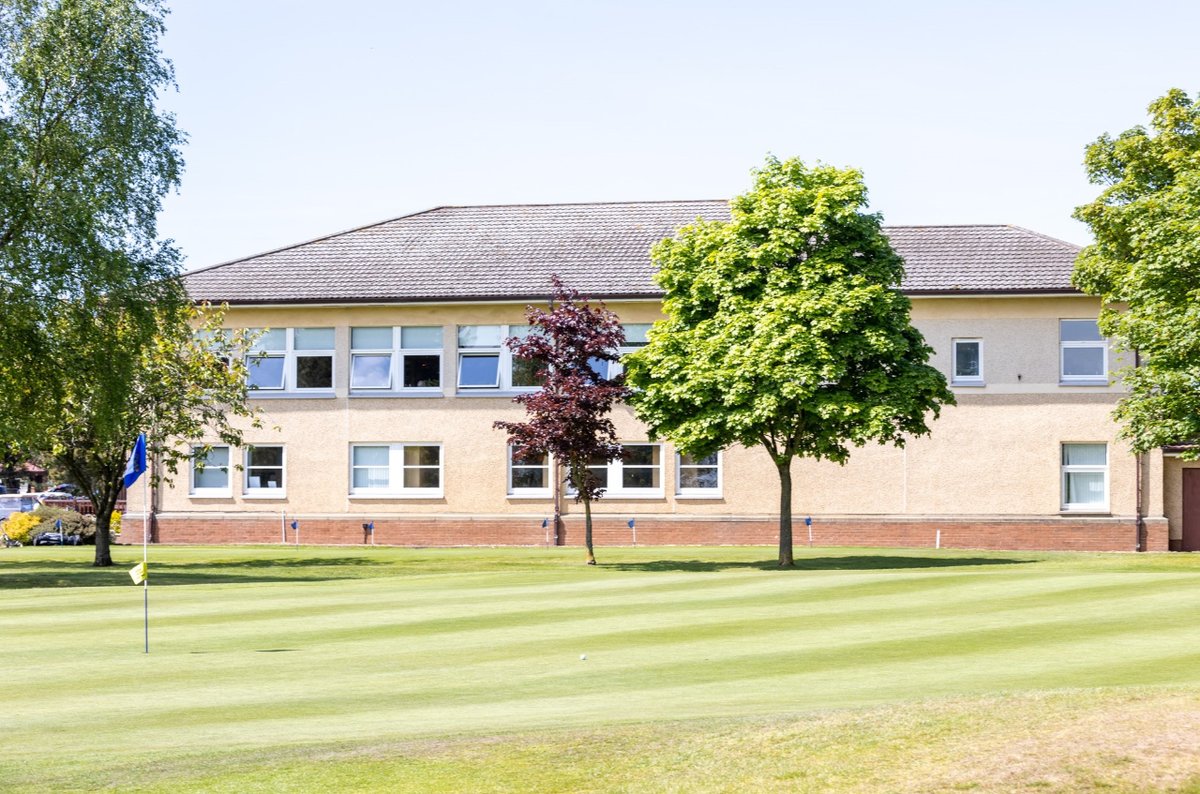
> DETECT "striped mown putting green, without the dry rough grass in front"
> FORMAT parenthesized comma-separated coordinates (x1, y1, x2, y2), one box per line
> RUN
(0, 547, 1200, 789)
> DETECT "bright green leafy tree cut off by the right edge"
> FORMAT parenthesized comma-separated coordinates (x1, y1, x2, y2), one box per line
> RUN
(1072, 89, 1200, 459)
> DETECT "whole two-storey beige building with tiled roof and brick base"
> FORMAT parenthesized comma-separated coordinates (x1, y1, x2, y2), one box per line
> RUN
(131, 201, 1180, 551)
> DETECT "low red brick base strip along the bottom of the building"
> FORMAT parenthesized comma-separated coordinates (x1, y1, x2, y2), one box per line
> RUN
(136, 515, 1168, 552)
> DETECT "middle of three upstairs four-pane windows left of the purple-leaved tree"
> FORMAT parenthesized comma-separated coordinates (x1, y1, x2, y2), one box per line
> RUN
(350, 325, 442, 391)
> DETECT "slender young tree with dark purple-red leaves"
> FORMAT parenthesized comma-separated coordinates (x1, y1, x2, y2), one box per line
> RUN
(494, 276, 629, 565)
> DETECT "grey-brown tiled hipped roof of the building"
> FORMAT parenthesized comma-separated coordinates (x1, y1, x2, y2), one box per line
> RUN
(184, 200, 1079, 303)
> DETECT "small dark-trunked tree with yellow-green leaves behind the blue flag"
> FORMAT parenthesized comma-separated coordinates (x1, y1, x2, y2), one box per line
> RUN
(43, 303, 260, 566)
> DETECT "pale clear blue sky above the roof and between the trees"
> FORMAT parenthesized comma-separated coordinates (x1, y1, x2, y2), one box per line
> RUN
(160, 0, 1200, 267)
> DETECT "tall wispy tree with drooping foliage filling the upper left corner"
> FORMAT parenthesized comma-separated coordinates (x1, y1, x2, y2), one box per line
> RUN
(0, 0, 184, 443)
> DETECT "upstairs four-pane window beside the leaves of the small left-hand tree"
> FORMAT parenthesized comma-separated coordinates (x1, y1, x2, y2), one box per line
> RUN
(246, 329, 334, 392)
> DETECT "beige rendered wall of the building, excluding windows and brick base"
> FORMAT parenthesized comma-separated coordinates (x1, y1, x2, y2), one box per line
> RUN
(131, 297, 1135, 519)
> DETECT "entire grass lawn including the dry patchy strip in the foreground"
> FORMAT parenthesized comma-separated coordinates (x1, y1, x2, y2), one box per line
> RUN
(0, 547, 1200, 792)
